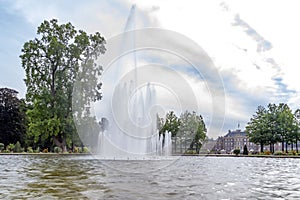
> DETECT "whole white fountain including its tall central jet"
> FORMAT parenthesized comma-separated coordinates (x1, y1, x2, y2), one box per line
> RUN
(93, 5, 172, 158)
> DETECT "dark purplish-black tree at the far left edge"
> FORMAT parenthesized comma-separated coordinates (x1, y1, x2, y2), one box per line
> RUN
(0, 88, 26, 145)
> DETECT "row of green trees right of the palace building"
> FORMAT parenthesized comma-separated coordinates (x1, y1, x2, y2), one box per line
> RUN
(246, 103, 300, 153)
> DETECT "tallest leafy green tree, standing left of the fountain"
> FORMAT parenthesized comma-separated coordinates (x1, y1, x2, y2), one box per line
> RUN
(20, 19, 105, 151)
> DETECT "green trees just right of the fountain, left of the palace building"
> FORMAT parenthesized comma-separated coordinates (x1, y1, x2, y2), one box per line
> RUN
(157, 111, 207, 153)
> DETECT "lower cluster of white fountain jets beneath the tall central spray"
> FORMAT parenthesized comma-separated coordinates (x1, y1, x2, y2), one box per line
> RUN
(97, 81, 172, 157)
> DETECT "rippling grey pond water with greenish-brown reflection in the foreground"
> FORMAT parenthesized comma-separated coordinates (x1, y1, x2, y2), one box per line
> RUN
(0, 155, 300, 200)
